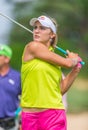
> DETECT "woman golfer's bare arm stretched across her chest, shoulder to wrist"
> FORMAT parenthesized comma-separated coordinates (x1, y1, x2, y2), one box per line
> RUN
(29, 42, 74, 68)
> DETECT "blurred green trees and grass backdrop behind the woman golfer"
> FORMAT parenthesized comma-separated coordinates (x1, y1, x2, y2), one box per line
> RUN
(0, 0, 88, 112)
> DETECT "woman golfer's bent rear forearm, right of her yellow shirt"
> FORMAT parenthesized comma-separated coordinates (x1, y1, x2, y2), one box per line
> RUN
(61, 60, 82, 95)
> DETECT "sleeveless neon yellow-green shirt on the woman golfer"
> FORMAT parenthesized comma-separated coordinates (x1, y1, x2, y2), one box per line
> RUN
(21, 49, 64, 109)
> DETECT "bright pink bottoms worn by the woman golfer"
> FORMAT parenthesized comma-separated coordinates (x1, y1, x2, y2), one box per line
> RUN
(22, 109, 67, 130)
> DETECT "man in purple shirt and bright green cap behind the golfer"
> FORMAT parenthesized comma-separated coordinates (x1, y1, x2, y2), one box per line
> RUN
(0, 44, 21, 130)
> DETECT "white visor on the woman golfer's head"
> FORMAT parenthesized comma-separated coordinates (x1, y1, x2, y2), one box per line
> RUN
(30, 16, 56, 34)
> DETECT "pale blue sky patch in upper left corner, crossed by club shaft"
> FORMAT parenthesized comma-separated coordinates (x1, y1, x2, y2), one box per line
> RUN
(0, 0, 13, 44)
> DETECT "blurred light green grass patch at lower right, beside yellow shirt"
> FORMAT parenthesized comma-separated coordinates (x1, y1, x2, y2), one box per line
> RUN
(67, 86, 88, 112)
